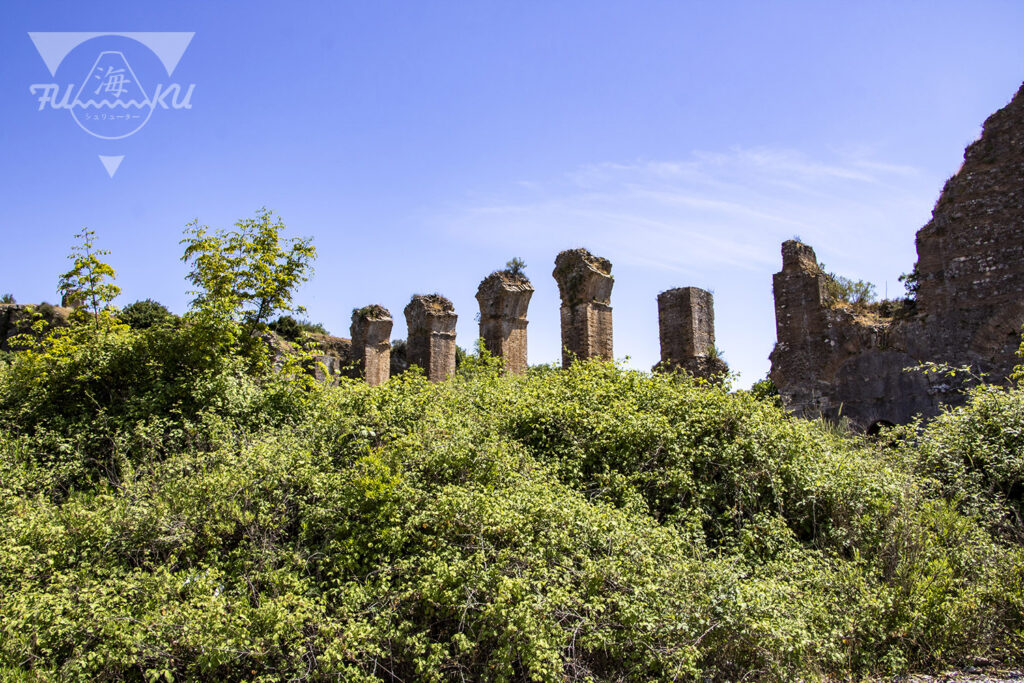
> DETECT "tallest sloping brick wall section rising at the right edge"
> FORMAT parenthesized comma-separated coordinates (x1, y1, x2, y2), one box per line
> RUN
(916, 87, 1024, 380)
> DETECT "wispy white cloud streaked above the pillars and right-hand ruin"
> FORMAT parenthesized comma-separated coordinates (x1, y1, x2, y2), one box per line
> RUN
(440, 147, 935, 278)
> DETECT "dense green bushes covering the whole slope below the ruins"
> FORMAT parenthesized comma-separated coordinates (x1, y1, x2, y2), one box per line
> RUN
(0, 222, 1024, 681)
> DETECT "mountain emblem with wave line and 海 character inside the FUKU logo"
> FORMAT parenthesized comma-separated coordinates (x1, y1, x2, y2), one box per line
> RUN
(71, 51, 153, 140)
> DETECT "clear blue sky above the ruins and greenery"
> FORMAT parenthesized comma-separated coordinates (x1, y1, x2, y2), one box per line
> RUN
(0, 0, 1024, 385)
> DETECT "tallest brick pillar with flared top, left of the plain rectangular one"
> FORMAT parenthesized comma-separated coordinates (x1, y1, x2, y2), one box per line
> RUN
(552, 249, 614, 368)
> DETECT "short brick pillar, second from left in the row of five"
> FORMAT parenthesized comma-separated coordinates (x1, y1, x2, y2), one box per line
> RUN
(406, 294, 459, 382)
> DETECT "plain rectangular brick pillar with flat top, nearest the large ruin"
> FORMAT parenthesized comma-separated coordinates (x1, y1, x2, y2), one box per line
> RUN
(657, 287, 729, 379)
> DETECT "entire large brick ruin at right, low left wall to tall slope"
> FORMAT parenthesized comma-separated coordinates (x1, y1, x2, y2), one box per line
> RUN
(771, 81, 1024, 431)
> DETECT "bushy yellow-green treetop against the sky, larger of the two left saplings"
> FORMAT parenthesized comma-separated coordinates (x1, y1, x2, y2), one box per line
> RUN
(181, 208, 316, 337)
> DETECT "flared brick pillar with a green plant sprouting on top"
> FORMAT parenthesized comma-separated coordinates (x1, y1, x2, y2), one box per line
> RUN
(476, 270, 534, 375)
